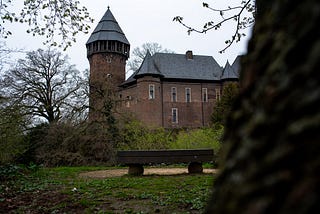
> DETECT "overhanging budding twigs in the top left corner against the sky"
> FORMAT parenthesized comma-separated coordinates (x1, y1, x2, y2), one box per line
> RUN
(0, 0, 93, 49)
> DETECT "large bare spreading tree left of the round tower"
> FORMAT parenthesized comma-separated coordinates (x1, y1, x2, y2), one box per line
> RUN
(1, 49, 87, 123)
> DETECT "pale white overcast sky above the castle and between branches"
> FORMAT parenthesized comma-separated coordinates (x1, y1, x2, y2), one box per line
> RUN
(6, 0, 250, 76)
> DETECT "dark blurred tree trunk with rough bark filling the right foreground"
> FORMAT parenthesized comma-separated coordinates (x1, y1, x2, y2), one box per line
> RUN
(207, 0, 320, 213)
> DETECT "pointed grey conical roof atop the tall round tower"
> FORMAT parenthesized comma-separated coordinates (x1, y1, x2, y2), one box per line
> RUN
(86, 7, 130, 45)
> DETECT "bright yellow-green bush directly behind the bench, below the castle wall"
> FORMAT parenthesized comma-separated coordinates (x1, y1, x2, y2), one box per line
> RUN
(117, 120, 223, 155)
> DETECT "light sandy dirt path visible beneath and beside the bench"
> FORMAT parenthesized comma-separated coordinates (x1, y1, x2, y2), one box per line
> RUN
(79, 168, 217, 178)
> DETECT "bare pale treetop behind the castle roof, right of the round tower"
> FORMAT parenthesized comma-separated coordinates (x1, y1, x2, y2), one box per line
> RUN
(128, 42, 174, 71)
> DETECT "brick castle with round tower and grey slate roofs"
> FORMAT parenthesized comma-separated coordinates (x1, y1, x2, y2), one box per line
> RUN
(86, 8, 240, 128)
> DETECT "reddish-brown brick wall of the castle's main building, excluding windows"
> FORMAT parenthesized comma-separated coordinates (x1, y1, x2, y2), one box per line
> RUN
(120, 77, 220, 128)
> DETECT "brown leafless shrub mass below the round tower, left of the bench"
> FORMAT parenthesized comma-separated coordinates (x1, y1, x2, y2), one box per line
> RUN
(34, 123, 115, 166)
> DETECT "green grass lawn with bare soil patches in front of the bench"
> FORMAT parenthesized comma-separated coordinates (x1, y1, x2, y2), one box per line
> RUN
(0, 167, 214, 213)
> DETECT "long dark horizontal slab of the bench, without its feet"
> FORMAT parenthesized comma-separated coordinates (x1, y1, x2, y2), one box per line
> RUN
(117, 149, 213, 164)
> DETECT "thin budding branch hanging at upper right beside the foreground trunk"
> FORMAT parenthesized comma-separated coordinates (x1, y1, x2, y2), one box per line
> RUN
(173, 0, 256, 53)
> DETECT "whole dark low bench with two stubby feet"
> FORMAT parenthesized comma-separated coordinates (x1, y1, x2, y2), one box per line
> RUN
(117, 149, 213, 175)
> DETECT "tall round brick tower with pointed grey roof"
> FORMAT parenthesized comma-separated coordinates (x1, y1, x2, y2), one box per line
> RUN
(86, 7, 130, 121)
